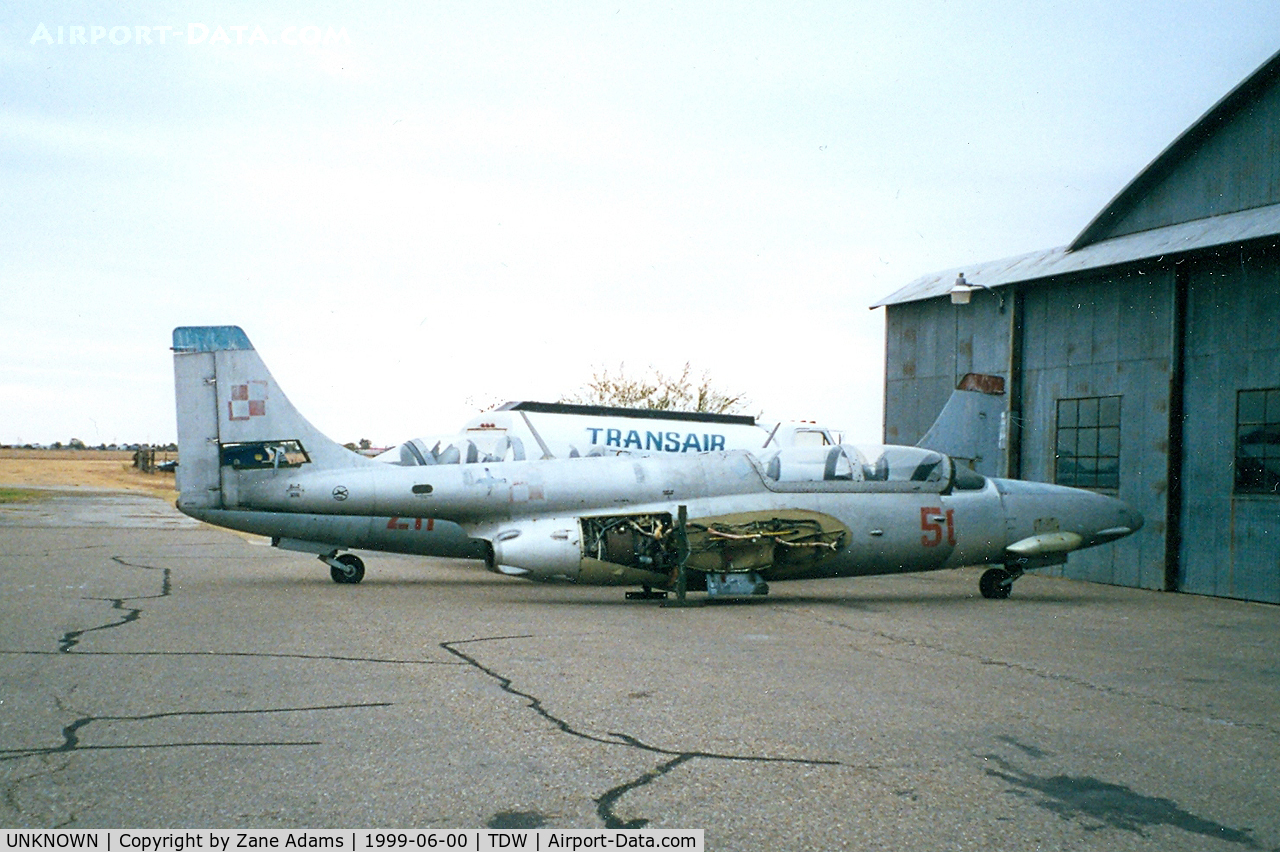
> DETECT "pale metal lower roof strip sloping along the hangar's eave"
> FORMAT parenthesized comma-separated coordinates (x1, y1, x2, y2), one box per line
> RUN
(872, 205, 1280, 308)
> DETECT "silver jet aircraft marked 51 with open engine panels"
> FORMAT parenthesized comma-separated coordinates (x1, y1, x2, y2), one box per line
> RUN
(173, 326, 1142, 599)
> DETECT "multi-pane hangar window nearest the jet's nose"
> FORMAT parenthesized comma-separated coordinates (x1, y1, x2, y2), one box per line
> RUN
(1053, 397, 1120, 490)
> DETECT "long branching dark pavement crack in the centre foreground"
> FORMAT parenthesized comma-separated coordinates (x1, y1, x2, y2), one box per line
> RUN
(440, 635, 845, 829)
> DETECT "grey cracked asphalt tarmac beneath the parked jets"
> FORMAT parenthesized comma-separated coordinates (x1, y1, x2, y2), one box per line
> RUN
(0, 494, 1280, 851)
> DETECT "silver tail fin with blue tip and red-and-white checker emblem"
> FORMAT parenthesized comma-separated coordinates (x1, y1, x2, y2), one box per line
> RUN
(173, 325, 374, 509)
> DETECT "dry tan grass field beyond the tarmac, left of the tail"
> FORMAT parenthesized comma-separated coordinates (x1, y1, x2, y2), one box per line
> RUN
(0, 448, 174, 493)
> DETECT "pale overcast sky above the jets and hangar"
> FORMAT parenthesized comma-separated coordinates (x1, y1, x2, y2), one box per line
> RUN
(0, 0, 1280, 445)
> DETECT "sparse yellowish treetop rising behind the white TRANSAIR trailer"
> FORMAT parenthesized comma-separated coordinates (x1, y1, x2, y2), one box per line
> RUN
(561, 362, 750, 414)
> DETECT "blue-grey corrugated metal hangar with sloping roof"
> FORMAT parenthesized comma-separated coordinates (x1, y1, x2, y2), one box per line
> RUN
(876, 54, 1280, 603)
